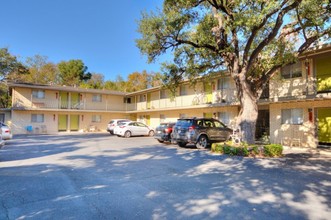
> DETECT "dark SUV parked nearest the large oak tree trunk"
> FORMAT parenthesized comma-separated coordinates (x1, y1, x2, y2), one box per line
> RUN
(173, 118, 232, 149)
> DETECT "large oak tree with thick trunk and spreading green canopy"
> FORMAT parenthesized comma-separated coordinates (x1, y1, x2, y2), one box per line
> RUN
(137, 0, 331, 143)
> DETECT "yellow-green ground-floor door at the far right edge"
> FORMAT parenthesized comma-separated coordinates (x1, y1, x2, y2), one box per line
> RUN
(317, 108, 331, 144)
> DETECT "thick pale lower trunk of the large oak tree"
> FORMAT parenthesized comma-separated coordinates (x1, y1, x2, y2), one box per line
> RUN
(237, 75, 258, 144)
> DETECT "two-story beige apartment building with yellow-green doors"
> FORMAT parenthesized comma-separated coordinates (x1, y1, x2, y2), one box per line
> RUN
(5, 46, 331, 147)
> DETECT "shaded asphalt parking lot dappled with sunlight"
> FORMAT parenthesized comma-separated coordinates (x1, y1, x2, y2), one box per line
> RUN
(0, 134, 331, 219)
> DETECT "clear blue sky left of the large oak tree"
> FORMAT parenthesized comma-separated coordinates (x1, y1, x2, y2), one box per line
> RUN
(0, 0, 163, 80)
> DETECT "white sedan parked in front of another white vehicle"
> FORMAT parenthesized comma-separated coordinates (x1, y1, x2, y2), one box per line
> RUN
(114, 121, 154, 138)
